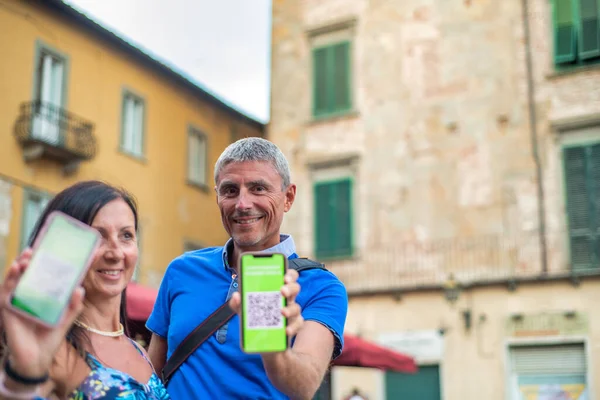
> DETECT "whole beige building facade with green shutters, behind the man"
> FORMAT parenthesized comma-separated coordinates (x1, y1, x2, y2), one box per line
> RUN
(267, 0, 600, 400)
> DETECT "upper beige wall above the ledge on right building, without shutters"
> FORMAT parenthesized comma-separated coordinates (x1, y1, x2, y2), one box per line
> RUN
(268, 0, 600, 276)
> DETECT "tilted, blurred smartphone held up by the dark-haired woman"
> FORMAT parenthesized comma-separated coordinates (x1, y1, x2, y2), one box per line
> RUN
(8, 211, 101, 327)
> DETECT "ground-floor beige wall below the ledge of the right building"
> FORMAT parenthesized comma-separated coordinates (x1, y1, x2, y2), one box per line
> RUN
(332, 280, 600, 400)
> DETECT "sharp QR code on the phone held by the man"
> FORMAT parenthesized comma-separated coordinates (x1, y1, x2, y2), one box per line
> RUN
(246, 292, 283, 329)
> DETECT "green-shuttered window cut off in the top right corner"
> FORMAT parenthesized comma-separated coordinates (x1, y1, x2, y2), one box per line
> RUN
(553, 0, 600, 66)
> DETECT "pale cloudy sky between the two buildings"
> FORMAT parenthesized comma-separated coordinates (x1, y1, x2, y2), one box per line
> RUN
(64, 0, 271, 122)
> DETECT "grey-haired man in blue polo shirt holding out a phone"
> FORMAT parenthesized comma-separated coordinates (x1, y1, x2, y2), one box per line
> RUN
(147, 138, 348, 400)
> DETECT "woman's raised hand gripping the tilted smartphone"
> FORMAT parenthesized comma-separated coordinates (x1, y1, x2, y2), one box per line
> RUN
(0, 249, 84, 378)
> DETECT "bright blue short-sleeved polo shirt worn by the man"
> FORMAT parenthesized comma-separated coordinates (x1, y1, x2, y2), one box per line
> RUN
(146, 235, 348, 400)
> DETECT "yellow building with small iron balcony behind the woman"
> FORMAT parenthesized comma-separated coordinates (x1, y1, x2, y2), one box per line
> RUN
(0, 0, 263, 287)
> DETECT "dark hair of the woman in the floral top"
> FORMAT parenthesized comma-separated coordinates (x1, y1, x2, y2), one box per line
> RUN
(29, 181, 138, 354)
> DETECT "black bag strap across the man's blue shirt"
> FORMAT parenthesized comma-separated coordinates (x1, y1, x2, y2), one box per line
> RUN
(162, 258, 325, 386)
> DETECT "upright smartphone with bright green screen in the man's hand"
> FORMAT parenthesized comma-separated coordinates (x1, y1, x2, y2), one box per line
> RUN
(239, 253, 289, 353)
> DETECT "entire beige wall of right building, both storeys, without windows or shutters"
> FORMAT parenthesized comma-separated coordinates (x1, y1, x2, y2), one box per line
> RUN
(268, 0, 600, 400)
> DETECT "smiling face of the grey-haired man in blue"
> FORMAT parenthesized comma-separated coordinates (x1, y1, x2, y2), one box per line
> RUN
(215, 161, 296, 251)
